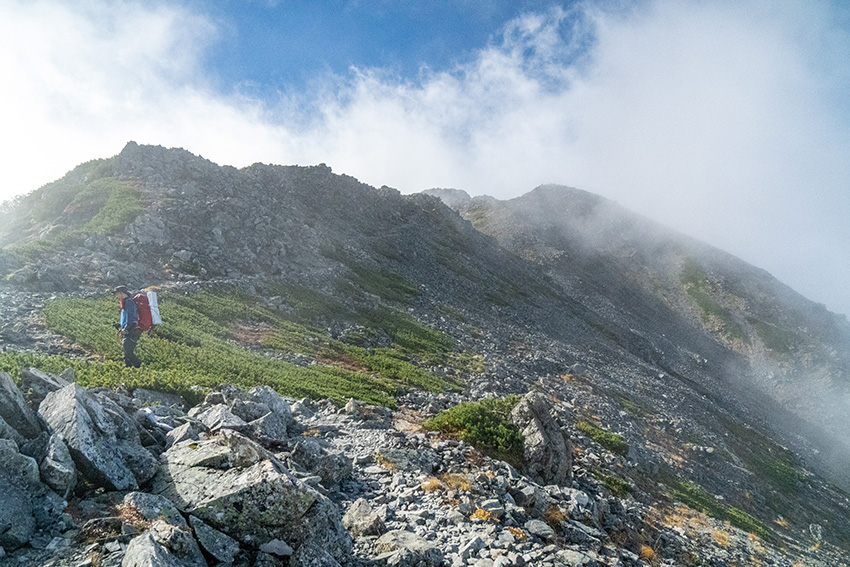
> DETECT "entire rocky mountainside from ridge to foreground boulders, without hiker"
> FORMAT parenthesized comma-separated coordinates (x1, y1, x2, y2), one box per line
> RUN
(0, 143, 850, 567)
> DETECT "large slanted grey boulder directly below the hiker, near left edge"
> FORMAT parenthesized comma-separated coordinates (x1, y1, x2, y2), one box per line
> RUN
(39, 384, 156, 490)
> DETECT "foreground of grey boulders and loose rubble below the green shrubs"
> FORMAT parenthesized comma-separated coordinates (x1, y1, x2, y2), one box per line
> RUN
(0, 369, 841, 567)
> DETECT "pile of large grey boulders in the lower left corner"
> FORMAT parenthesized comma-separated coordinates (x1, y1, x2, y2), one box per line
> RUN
(0, 369, 351, 567)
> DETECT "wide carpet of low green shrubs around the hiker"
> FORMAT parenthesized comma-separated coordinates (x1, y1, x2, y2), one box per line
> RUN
(29, 288, 458, 407)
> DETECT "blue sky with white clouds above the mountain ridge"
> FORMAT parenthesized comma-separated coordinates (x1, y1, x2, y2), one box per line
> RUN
(0, 0, 850, 320)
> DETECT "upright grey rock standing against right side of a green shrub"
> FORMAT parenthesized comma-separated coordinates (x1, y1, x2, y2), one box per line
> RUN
(511, 392, 573, 484)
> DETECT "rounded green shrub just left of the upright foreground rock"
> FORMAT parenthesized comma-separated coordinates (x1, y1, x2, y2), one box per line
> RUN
(424, 396, 524, 468)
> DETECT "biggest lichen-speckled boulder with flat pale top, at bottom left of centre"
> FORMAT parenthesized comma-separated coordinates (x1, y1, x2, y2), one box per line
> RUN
(153, 429, 351, 559)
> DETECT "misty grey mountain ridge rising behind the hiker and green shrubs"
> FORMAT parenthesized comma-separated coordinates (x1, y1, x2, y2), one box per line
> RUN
(0, 143, 850, 564)
